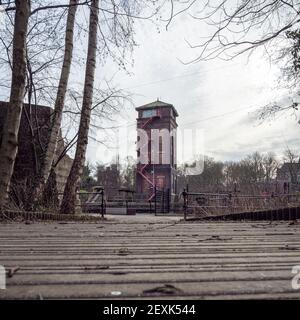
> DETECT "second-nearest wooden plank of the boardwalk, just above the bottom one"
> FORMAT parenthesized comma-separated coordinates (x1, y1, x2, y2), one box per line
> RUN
(3, 269, 293, 286)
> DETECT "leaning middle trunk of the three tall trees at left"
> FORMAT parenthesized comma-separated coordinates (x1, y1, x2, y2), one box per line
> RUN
(31, 0, 78, 205)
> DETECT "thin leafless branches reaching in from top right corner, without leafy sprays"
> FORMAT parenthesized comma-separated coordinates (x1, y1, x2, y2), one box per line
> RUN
(171, 0, 300, 61)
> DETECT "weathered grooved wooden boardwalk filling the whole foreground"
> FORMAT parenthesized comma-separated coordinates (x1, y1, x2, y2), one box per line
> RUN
(0, 215, 300, 299)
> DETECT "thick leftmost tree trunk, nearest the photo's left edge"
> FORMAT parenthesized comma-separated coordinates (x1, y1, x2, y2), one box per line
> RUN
(0, 0, 30, 208)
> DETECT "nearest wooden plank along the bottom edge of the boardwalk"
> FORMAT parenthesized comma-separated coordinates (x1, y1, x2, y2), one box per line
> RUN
(0, 280, 295, 299)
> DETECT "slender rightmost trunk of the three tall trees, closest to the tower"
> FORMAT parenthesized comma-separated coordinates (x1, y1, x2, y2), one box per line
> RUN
(60, 0, 99, 214)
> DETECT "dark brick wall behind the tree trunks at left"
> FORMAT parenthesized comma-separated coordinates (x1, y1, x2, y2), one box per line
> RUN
(0, 102, 72, 206)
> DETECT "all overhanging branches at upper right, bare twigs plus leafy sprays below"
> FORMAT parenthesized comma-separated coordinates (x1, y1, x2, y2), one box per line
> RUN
(169, 0, 300, 121)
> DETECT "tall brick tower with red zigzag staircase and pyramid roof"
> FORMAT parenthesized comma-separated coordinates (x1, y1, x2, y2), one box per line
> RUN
(136, 100, 178, 200)
